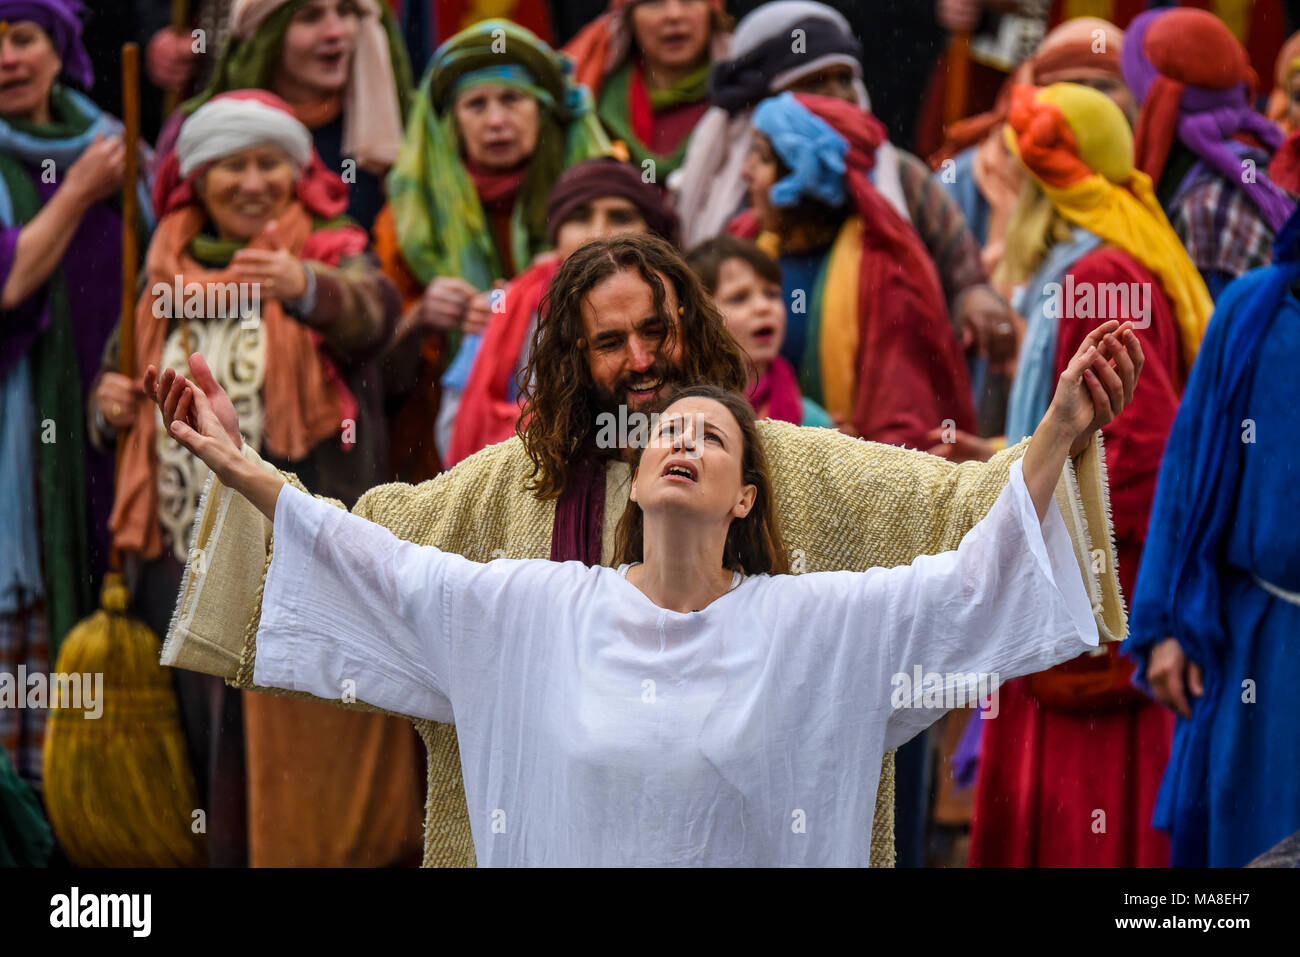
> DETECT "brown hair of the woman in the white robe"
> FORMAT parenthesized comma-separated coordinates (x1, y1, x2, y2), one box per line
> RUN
(614, 385, 790, 575)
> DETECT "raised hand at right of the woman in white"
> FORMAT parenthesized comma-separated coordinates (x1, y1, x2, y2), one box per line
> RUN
(1045, 320, 1145, 455)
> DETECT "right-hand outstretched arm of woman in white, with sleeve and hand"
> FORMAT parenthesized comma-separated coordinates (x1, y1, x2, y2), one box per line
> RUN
(774, 322, 1141, 748)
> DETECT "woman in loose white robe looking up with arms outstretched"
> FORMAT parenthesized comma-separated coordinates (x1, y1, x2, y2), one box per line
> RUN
(146, 322, 1143, 866)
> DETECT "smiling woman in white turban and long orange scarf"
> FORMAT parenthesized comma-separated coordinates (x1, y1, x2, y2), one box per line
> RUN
(112, 90, 419, 865)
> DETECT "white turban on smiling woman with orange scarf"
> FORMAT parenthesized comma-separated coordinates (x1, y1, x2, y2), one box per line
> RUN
(176, 96, 312, 179)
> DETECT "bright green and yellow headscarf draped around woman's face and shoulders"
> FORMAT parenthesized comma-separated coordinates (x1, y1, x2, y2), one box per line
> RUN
(387, 20, 610, 289)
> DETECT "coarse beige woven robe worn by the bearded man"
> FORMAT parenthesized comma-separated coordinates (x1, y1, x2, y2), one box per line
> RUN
(163, 420, 1127, 867)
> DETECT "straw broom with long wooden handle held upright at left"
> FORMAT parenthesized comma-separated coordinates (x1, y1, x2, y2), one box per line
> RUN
(44, 43, 207, 867)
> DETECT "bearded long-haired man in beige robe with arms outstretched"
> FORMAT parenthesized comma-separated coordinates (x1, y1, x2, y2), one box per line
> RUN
(146, 235, 1131, 866)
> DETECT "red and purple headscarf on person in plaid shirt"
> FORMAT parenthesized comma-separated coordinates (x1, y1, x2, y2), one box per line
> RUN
(1121, 8, 1295, 233)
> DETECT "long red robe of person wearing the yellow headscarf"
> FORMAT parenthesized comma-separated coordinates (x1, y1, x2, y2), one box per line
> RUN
(970, 247, 1187, 867)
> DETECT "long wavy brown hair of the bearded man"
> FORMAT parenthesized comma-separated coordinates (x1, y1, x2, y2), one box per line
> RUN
(515, 235, 746, 498)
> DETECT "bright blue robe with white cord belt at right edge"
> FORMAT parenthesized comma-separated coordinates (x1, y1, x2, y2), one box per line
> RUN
(1123, 215, 1300, 867)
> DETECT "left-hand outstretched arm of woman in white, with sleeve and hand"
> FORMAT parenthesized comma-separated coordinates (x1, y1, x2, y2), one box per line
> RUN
(146, 355, 471, 722)
